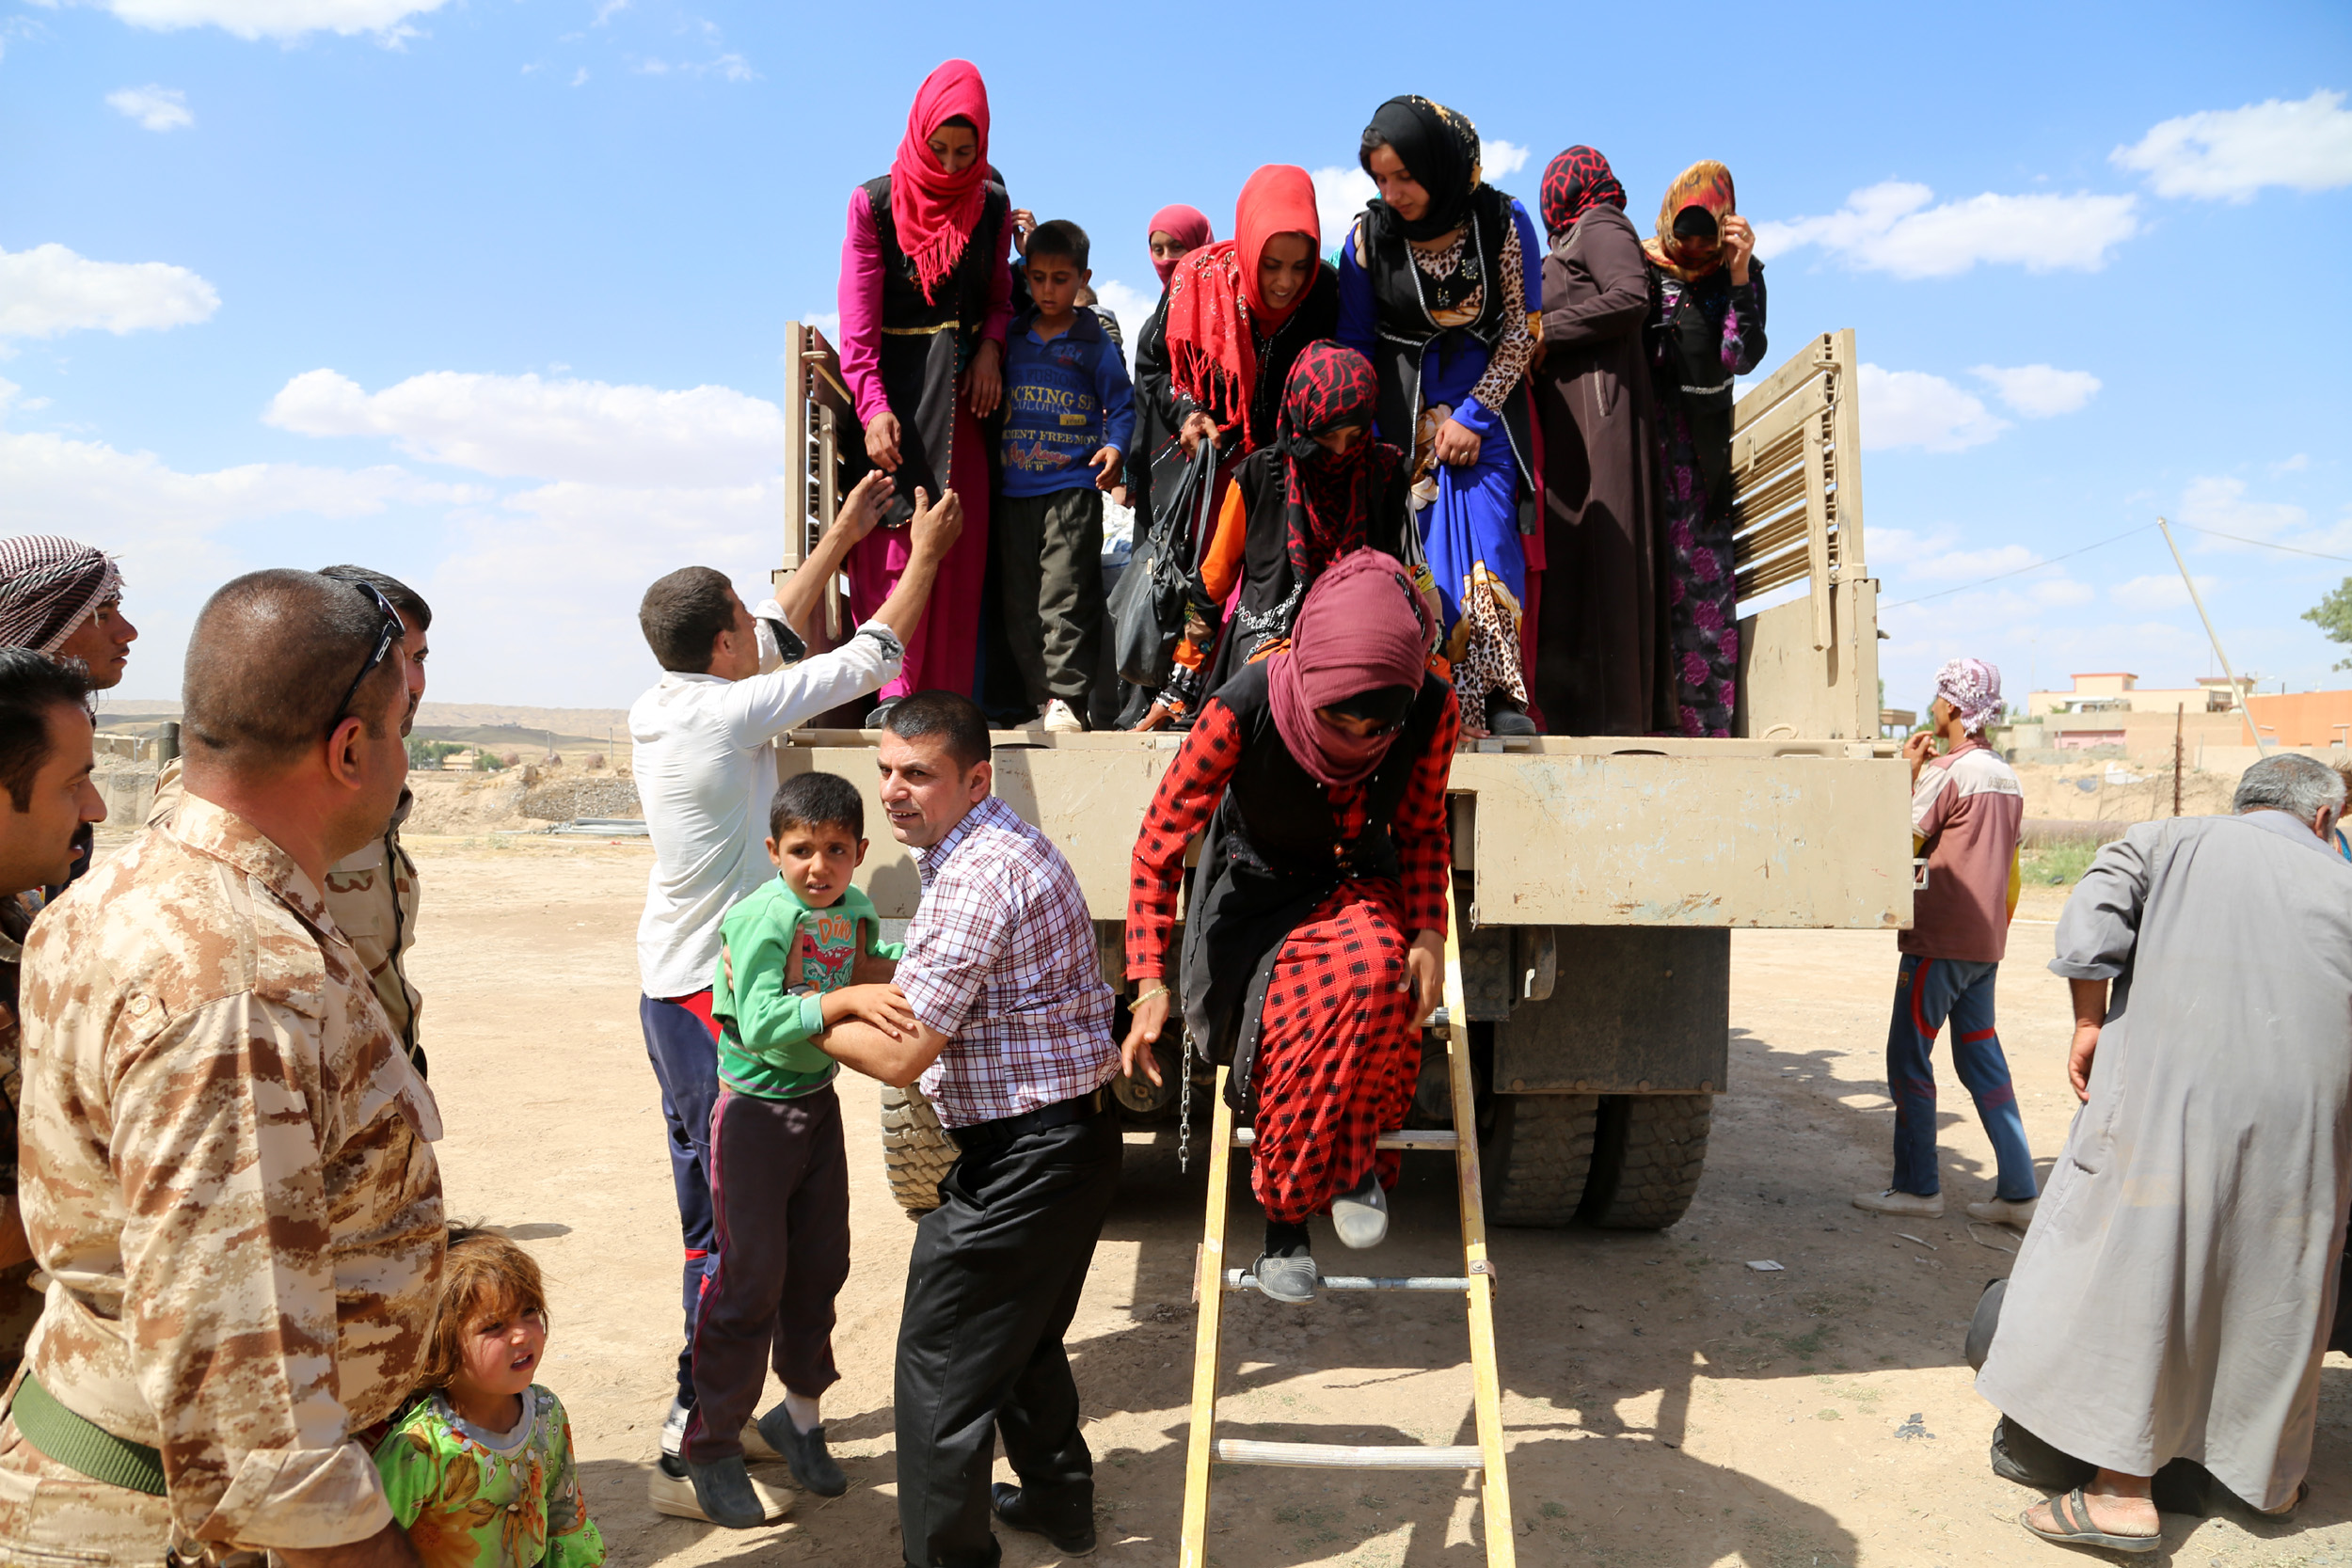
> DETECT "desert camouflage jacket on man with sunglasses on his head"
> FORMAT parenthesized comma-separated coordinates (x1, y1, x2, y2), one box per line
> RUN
(19, 797, 442, 1547)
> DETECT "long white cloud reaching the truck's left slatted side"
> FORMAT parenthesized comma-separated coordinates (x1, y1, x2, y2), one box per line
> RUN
(263, 369, 784, 486)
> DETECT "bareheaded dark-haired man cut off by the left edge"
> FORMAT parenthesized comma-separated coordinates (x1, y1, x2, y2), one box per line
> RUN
(0, 649, 106, 1380)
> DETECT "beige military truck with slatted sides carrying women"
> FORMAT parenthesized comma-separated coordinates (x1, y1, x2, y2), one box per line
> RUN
(776, 322, 1913, 1229)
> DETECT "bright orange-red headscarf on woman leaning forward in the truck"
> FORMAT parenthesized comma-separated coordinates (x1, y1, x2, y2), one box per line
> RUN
(1167, 162, 1322, 447)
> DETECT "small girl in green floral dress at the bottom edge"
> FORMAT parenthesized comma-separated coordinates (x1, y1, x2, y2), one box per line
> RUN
(376, 1229, 605, 1568)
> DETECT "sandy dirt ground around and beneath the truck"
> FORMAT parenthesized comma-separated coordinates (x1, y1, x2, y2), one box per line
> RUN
(412, 837, 2352, 1568)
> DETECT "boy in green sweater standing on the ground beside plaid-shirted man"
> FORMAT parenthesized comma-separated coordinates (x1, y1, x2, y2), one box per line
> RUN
(685, 773, 915, 1530)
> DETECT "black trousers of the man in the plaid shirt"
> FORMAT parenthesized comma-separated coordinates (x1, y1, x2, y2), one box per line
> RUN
(897, 1110, 1120, 1568)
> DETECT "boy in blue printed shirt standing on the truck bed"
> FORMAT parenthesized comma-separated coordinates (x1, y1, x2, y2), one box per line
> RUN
(995, 218, 1136, 734)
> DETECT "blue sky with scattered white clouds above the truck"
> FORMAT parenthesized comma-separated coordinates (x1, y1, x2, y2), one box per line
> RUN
(0, 0, 2352, 707)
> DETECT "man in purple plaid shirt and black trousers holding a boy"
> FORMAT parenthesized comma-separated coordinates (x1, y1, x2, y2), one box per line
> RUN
(817, 691, 1120, 1568)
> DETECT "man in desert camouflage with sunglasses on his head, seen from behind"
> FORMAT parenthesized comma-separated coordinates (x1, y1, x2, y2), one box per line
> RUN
(0, 571, 445, 1568)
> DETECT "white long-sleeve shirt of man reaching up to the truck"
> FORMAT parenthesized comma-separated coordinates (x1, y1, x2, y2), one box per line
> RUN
(628, 620, 906, 997)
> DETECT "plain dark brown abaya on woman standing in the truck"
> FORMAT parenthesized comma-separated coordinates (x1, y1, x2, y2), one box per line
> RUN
(1534, 204, 1670, 736)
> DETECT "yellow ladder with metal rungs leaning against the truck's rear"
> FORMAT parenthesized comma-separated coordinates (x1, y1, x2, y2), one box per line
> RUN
(1176, 889, 1518, 1568)
